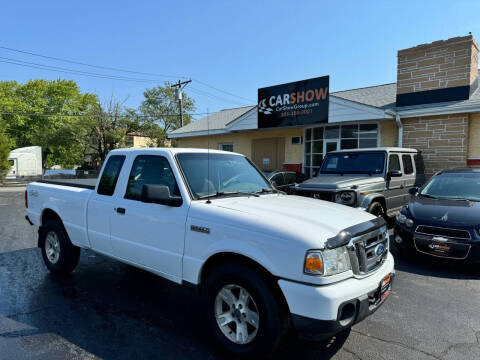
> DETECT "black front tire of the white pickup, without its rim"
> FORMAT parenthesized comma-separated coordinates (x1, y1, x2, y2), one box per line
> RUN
(204, 264, 289, 357)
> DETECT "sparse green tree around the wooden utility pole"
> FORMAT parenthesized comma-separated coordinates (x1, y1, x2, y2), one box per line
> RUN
(139, 82, 195, 146)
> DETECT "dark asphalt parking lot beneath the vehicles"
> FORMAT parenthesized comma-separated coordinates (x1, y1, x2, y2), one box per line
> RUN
(0, 188, 480, 360)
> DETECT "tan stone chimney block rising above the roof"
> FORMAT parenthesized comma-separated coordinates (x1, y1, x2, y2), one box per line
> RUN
(397, 35, 478, 94)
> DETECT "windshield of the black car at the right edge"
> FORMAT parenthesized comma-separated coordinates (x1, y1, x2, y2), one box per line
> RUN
(420, 172, 480, 201)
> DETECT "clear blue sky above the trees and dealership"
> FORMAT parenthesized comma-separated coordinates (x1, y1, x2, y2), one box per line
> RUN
(0, 0, 480, 118)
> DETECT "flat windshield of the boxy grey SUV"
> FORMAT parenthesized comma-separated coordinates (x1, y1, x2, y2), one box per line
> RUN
(319, 152, 385, 175)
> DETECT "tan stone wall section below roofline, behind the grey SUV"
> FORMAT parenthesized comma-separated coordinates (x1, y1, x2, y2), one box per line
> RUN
(402, 114, 469, 176)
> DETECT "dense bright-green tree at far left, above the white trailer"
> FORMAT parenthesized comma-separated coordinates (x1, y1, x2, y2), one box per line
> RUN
(0, 79, 98, 168)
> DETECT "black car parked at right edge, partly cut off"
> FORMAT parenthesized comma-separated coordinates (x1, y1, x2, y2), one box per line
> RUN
(393, 168, 480, 262)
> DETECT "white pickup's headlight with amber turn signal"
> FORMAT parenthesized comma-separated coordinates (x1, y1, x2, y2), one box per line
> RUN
(303, 246, 351, 276)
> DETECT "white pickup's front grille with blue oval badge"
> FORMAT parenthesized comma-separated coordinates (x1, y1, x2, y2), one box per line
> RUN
(347, 226, 389, 276)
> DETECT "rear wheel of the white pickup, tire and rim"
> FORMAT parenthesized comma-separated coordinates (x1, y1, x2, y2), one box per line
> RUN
(40, 220, 80, 274)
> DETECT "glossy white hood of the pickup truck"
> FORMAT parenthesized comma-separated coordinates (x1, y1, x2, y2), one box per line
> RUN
(197, 194, 375, 248)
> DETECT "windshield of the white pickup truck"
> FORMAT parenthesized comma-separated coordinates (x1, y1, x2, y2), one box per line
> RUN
(177, 153, 273, 199)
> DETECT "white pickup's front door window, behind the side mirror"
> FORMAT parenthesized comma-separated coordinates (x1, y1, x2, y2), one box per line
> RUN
(125, 155, 180, 200)
